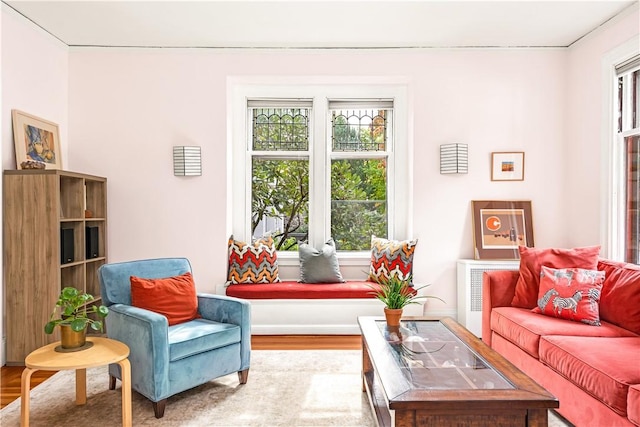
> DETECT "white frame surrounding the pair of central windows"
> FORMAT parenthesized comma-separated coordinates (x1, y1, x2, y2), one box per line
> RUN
(227, 77, 413, 267)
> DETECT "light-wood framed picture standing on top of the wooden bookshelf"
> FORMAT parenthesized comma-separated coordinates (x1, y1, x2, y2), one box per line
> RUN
(11, 110, 62, 169)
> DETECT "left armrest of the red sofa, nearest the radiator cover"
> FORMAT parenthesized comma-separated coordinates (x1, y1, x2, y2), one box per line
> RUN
(482, 270, 520, 346)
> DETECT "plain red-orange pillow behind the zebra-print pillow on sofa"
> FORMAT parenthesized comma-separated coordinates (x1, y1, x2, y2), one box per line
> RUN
(511, 246, 600, 308)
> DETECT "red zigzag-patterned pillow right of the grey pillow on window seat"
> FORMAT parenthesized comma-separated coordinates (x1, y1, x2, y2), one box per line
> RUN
(369, 236, 418, 282)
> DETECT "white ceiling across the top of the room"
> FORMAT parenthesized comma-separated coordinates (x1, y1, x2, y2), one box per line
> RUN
(2, 0, 640, 48)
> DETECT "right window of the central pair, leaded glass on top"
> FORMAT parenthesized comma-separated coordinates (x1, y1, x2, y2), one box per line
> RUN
(329, 101, 393, 251)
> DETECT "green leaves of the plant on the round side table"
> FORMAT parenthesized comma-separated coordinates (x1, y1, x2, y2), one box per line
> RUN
(44, 286, 109, 334)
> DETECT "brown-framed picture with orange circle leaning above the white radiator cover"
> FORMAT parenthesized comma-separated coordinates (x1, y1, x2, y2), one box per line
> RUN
(471, 200, 534, 259)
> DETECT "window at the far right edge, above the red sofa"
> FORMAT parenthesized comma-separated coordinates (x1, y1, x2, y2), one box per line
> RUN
(616, 57, 640, 264)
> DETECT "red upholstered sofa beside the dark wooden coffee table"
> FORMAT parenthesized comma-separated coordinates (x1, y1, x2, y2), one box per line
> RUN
(482, 259, 640, 427)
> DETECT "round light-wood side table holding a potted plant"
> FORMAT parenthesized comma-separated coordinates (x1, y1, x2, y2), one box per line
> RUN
(20, 337, 132, 427)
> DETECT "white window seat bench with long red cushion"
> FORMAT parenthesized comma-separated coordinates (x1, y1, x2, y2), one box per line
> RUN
(217, 280, 424, 335)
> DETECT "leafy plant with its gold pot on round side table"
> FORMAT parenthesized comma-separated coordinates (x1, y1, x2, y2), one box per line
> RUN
(44, 286, 109, 349)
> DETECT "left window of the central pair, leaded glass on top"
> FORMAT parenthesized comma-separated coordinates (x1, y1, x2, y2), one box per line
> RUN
(247, 100, 312, 251)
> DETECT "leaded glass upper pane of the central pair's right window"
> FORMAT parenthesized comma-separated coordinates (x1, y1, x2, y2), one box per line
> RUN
(331, 109, 391, 151)
